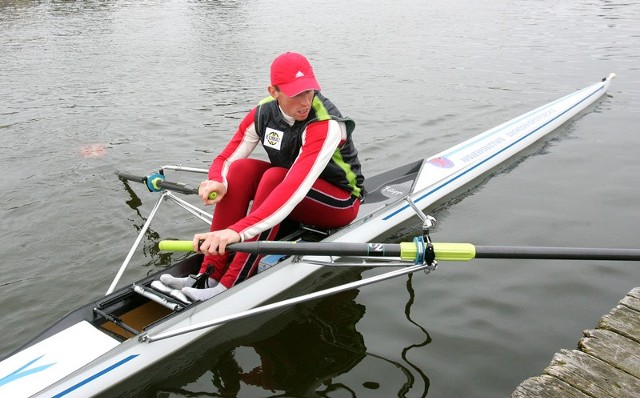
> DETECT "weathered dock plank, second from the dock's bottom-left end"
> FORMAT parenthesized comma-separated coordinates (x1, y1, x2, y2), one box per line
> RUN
(544, 350, 640, 398)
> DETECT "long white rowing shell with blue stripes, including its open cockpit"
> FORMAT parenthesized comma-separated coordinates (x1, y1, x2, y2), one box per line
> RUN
(0, 74, 615, 397)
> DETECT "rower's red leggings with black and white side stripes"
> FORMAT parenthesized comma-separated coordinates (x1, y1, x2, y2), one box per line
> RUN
(200, 159, 360, 288)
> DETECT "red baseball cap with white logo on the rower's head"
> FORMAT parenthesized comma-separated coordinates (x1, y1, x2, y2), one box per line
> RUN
(271, 52, 320, 97)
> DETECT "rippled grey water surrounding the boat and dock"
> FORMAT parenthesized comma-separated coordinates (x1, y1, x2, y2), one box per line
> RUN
(0, 0, 640, 397)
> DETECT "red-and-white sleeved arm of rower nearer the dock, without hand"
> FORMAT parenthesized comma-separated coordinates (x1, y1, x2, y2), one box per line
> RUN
(229, 120, 343, 240)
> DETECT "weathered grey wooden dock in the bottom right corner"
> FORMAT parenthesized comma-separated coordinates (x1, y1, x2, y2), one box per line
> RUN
(511, 287, 640, 398)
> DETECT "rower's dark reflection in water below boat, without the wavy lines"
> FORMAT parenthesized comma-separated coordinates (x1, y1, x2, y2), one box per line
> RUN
(158, 290, 366, 396)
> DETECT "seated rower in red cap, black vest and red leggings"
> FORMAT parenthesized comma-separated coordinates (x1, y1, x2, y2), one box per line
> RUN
(160, 52, 364, 301)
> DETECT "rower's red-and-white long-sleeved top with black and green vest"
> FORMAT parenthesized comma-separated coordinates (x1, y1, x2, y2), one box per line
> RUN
(209, 92, 364, 240)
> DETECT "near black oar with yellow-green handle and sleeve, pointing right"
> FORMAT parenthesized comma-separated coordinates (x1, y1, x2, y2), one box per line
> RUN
(159, 239, 640, 261)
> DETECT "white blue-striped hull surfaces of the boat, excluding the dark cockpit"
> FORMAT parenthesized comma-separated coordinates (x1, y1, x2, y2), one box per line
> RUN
(0, 75, 613, 397)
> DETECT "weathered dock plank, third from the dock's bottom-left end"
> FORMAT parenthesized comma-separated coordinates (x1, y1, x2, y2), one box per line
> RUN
(578, 329, 640, 377)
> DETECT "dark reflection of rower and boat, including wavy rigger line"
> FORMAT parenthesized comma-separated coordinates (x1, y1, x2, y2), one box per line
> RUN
(155, 270, 431, 397)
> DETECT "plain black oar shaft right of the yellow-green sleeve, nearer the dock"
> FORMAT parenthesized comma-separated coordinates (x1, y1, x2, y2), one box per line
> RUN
(475, 246, 640, 261)
